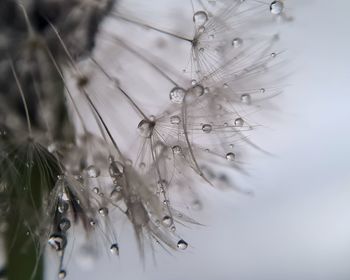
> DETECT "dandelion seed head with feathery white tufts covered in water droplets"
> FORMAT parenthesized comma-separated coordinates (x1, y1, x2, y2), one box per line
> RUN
(0, 0, 288, 280)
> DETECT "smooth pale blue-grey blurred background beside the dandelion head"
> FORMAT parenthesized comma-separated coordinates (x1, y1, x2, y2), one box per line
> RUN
(47, 0, 350, 280)
